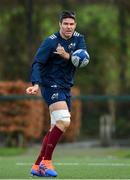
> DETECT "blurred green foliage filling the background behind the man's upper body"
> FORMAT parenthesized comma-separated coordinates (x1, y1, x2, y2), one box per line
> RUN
(0, 0, 130, 138)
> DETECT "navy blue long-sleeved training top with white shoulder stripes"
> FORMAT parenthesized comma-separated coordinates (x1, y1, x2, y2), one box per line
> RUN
(31, 31, 86, 88)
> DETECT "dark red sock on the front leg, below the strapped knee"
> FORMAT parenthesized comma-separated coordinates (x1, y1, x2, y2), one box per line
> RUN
(44, 126, 63, 160)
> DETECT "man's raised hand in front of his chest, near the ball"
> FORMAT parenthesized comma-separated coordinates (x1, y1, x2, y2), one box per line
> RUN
(54, 44, 70, 60)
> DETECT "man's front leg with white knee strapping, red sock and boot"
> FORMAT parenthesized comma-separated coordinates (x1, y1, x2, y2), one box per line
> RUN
(41, 101, 70, 176)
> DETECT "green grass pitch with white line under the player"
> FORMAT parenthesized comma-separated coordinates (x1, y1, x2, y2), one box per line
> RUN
(0, 145, 130, 179)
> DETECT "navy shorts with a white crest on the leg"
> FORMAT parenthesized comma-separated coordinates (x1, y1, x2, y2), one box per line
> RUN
(41, 87, 71, 111)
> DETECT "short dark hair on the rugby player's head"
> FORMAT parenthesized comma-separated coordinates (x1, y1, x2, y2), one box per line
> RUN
(59, 10, 76, 22)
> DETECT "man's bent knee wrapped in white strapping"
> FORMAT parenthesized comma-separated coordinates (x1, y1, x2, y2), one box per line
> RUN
(51, 109, 70, 130)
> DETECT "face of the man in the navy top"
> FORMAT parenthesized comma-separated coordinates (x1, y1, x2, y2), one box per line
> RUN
(59, 18, 76, 39)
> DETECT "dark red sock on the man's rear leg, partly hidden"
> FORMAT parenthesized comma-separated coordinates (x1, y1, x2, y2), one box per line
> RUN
(35, 131, 50, 165)
